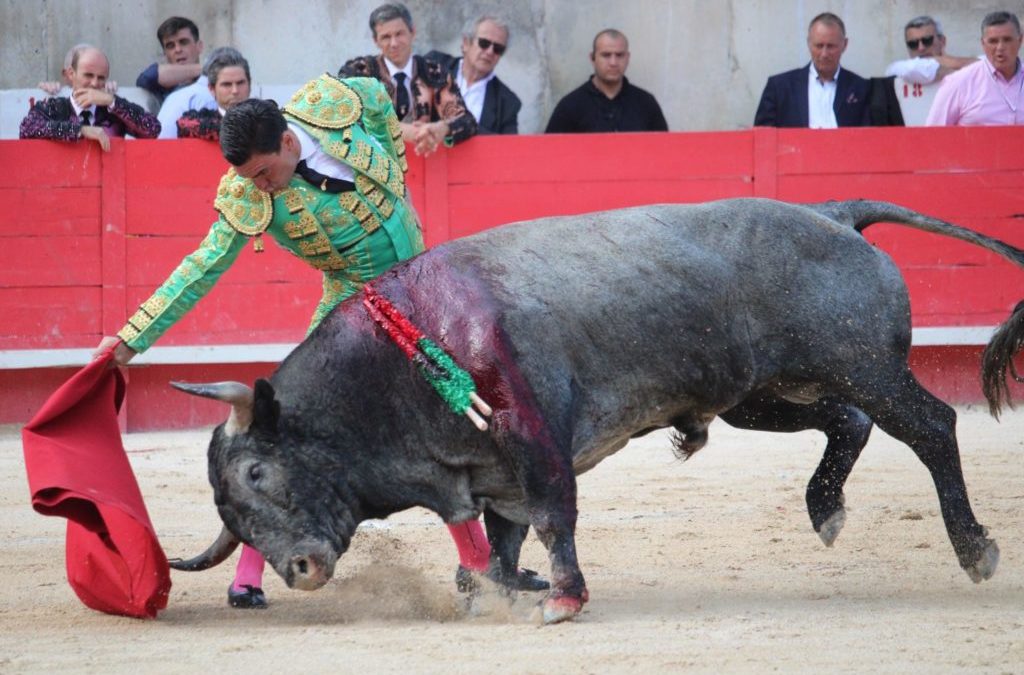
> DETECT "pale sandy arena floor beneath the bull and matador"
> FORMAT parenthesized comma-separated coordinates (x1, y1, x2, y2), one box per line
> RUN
(0, 409, 1024, 675)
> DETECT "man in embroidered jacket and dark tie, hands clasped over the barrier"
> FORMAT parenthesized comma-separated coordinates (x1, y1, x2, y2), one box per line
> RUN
(338, 2, 476, 155)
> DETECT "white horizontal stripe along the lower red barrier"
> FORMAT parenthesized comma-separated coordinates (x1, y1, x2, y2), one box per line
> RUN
(0, 326, 995, 370)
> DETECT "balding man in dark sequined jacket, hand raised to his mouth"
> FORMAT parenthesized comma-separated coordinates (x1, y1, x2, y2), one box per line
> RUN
(18, 47, 160, 151)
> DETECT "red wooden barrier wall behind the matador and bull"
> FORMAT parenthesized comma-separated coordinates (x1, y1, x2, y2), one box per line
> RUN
(0, 128, 1024, 429)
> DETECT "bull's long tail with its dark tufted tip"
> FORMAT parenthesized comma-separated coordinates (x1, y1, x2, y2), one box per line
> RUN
(809, 200, 1024, 418)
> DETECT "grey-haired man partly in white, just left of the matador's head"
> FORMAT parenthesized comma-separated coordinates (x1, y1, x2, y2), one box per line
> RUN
(160, 47, 252, 140)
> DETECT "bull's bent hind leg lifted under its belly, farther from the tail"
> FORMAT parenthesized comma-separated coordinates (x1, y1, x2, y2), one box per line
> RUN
(721, 391, 871, 546)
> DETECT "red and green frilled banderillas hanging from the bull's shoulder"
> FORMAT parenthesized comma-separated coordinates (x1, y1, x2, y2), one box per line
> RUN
(362, 286, 492, 431)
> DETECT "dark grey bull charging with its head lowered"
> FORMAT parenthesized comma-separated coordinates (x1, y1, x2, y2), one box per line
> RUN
(169, 199, 1024, 623)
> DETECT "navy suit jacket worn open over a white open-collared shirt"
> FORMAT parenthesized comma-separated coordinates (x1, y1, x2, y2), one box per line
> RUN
(754, 64, 870, 127)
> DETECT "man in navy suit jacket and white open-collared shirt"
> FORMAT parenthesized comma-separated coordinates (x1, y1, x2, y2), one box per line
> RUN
(754, 12, 870, 129)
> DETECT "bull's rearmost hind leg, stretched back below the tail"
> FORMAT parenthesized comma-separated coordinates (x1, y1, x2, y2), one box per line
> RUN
(858, 366, 999, 583)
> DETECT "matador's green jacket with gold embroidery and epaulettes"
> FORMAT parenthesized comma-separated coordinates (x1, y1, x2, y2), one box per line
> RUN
(118, 75, 423, 352)
